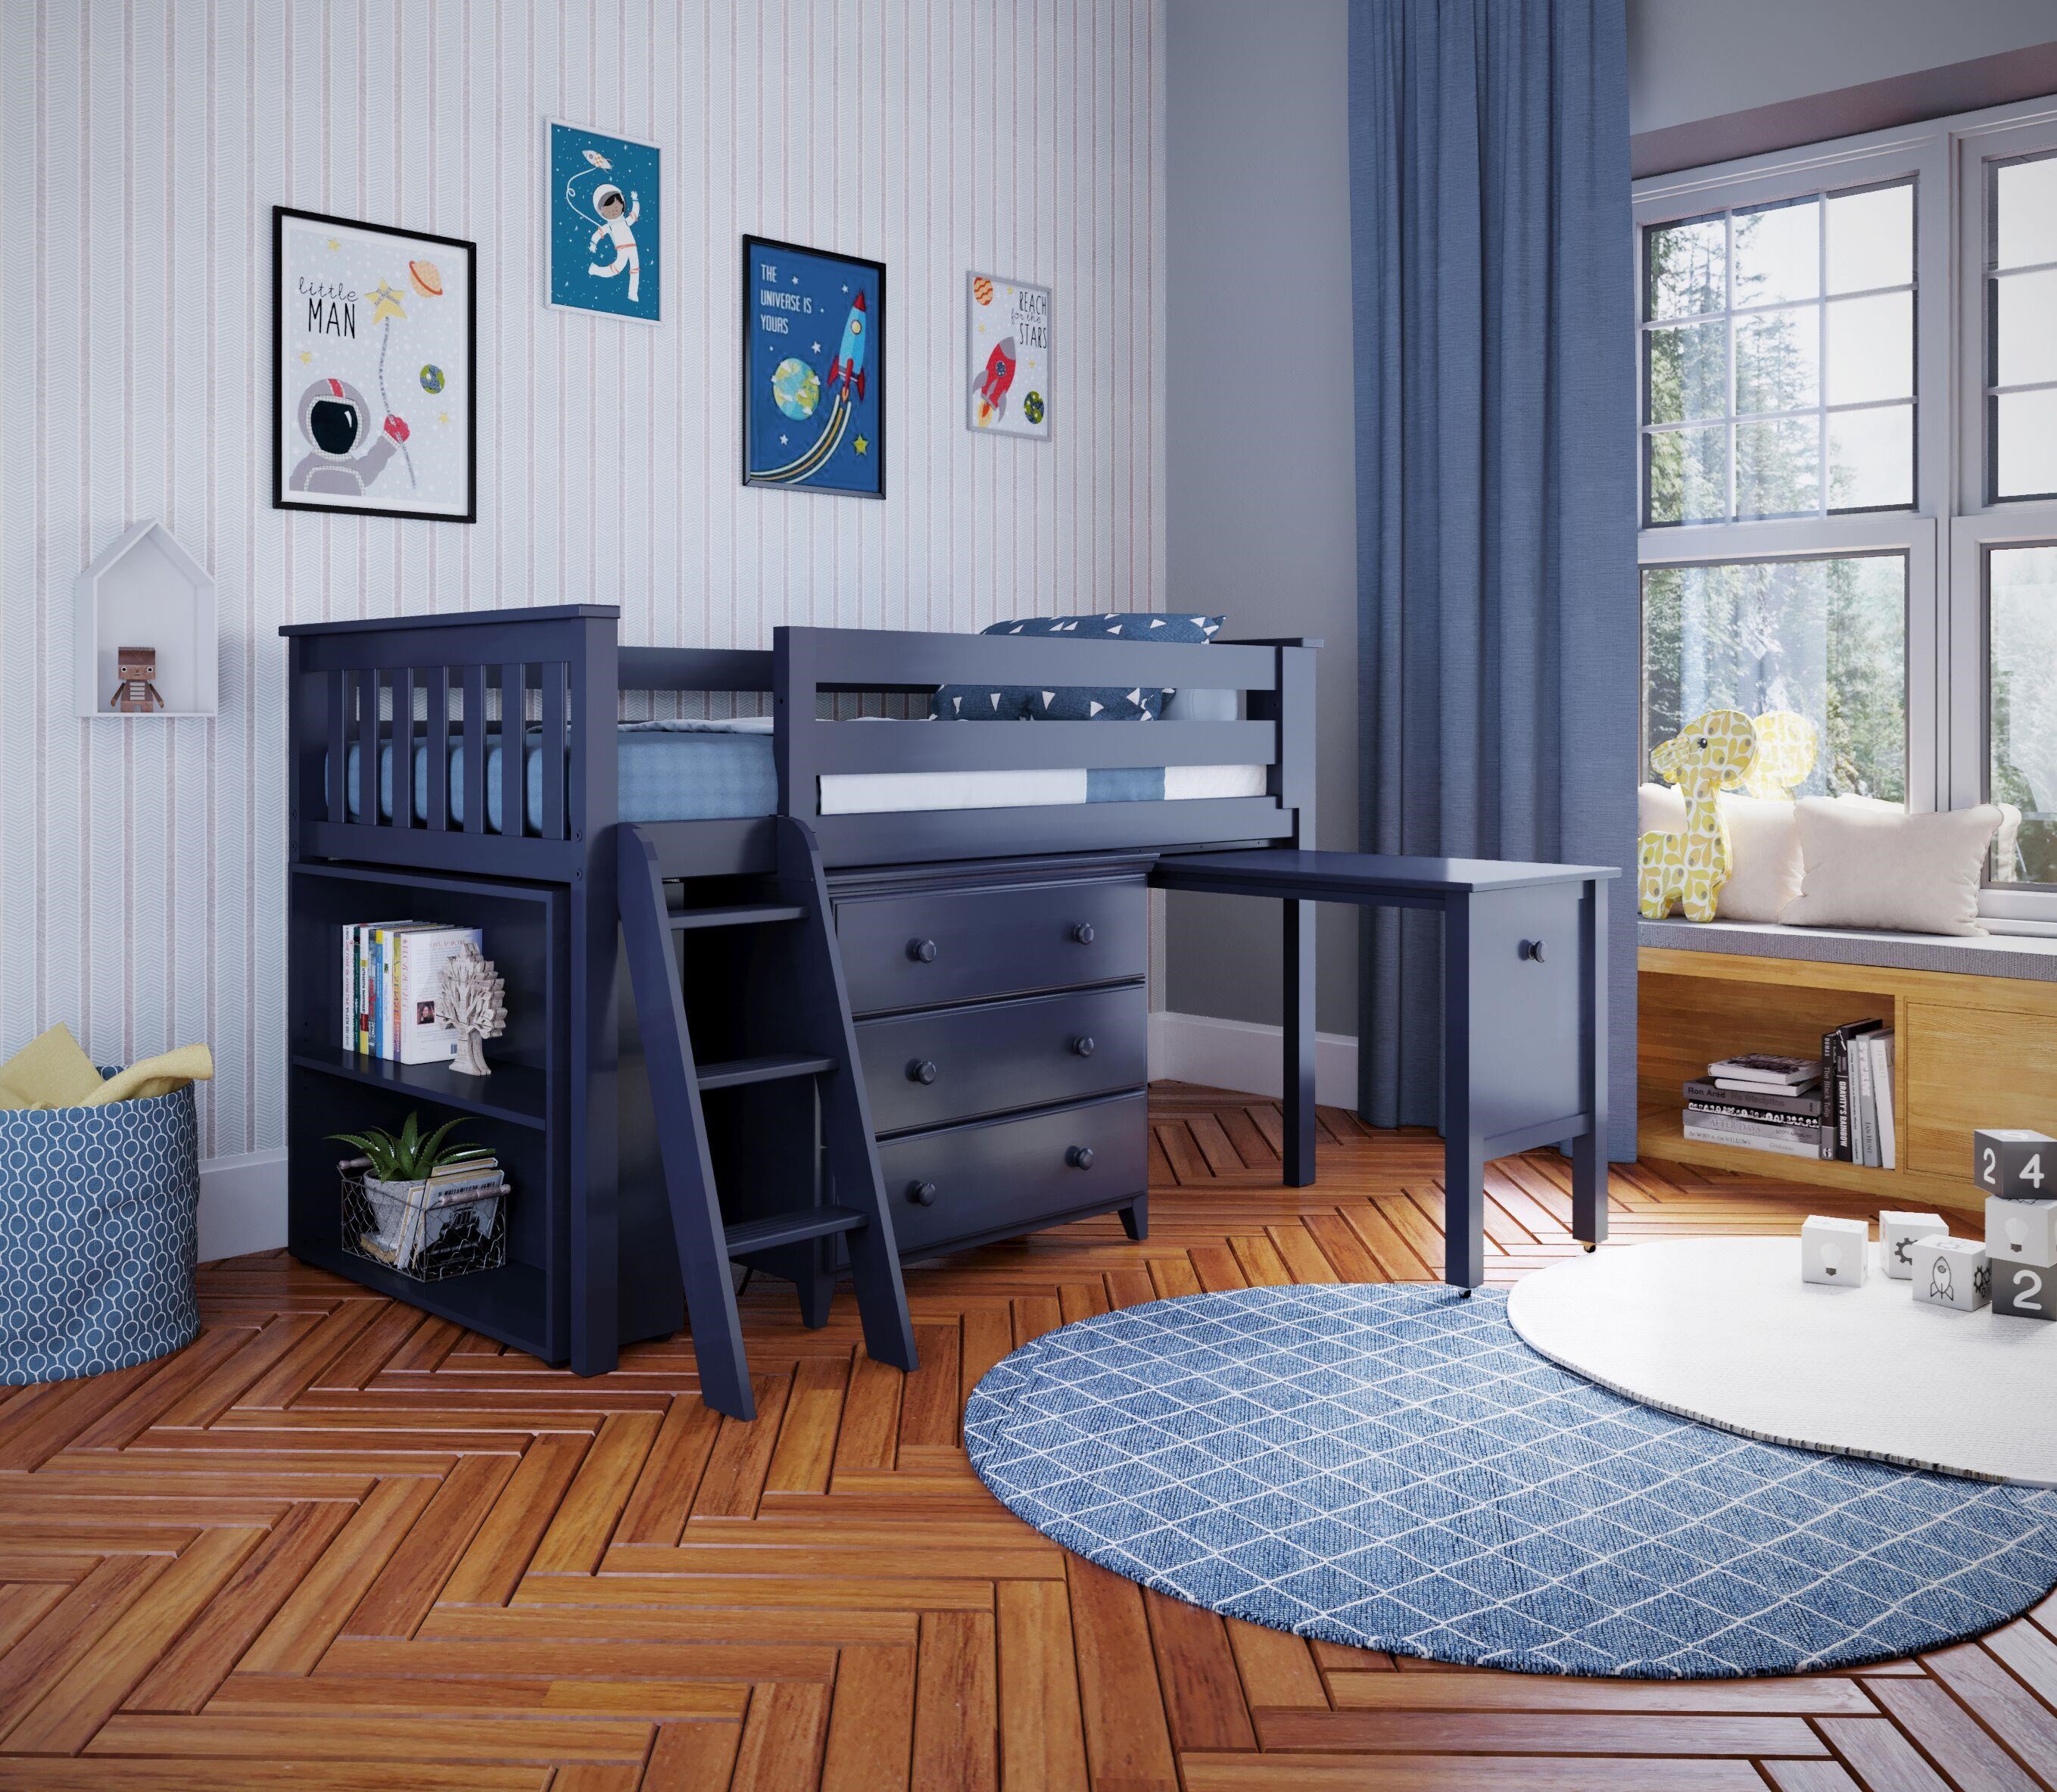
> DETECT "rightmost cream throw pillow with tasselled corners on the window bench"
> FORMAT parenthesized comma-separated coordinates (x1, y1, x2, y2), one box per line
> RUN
(1779, 796, 2003, 934)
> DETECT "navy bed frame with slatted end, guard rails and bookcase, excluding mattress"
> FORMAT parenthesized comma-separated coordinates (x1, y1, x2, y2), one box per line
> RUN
(282, 605, 1314, 1374)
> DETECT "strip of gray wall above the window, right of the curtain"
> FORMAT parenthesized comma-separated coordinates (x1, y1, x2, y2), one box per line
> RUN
(1620, 0, 2057, 132)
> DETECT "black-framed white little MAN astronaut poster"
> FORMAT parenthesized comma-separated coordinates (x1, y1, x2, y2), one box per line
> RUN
(272, 206, 477, 522)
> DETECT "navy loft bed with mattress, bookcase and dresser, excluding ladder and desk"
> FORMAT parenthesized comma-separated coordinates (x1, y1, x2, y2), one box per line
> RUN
(282, 605, 1314, 1373)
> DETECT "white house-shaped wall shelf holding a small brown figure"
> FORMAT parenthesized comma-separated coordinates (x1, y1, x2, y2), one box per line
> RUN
(72, 522, 216, 716)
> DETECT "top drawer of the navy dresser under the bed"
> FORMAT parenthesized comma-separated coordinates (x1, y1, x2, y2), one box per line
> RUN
(835, 878, 1150, 1014)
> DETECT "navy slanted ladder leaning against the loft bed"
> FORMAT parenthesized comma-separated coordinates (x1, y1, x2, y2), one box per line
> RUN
(619, 815, 915, 1420)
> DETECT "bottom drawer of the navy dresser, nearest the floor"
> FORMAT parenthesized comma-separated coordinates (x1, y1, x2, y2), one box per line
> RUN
(878, 1095, 1148, 1257)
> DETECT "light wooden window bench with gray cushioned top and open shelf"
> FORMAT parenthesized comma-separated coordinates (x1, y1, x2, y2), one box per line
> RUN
(1635, 921, 2057, 1208)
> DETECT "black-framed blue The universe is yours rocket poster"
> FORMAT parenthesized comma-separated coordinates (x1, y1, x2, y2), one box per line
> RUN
(743, 237, 887, 498)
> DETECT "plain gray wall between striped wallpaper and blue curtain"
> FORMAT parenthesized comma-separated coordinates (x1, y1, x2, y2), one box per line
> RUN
(1164, 0, 1357, 1033)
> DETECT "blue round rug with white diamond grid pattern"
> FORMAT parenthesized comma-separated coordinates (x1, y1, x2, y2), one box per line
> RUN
(965, 1284, 2057, 1679)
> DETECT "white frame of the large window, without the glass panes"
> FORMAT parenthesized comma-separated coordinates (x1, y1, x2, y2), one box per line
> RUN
(1633, 95, 2057, 932)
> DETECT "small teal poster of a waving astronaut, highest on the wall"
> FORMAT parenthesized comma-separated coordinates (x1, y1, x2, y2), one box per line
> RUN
(543, 117, 665, 323)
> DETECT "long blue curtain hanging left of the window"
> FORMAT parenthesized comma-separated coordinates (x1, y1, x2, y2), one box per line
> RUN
(1349, 0, 1641, 1158)
